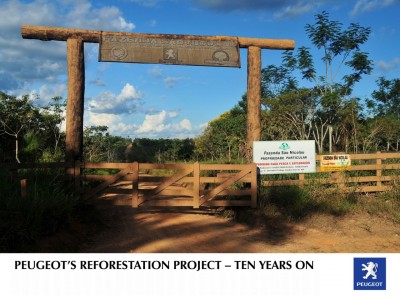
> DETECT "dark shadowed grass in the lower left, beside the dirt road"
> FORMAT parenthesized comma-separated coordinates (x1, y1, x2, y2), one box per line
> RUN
(0, 170, 100, 252)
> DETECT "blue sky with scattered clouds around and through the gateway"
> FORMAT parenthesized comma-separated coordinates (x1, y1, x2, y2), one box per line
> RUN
(0, 0, 400, 138)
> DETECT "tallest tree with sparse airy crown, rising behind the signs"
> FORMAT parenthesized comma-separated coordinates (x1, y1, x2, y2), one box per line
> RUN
(262, 11, 372, 153)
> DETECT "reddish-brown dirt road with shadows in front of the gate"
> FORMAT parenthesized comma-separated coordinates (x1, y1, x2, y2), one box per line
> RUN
(81, 205, 400, 253)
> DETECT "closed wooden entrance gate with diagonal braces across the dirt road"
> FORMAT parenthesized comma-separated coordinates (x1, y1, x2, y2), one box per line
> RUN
(81, 162, 257, 208)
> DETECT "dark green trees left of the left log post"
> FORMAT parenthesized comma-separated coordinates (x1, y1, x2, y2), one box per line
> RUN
(0, 92, 65, 162)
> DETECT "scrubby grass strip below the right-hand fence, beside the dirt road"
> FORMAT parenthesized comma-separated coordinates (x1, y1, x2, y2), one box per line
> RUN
(228, 170, 400, 226)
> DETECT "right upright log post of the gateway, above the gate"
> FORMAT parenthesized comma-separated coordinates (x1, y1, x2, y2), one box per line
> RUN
(246, 46, 261, 163)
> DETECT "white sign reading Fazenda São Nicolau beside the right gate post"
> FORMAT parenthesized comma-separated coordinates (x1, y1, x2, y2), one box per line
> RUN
(253, 140, 316, 175)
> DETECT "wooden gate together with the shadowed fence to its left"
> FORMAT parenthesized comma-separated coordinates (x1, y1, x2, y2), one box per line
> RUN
(0, 162, 257, 208)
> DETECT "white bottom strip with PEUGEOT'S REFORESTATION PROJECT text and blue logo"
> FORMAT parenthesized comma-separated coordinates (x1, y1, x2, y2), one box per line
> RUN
(0, 253, 400, 300)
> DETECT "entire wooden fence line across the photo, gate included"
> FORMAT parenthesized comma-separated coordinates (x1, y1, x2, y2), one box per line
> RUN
(0, 152, 400, 207)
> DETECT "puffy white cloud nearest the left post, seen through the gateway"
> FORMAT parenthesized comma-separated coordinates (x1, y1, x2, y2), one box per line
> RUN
(88, 83, 142, 115)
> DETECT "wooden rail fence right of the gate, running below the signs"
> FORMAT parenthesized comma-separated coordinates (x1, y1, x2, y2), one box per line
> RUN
(261, 152, 400, 193)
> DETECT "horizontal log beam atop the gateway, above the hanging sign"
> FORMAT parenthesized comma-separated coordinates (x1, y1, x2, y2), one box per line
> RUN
(21, 25, 294, 50)
